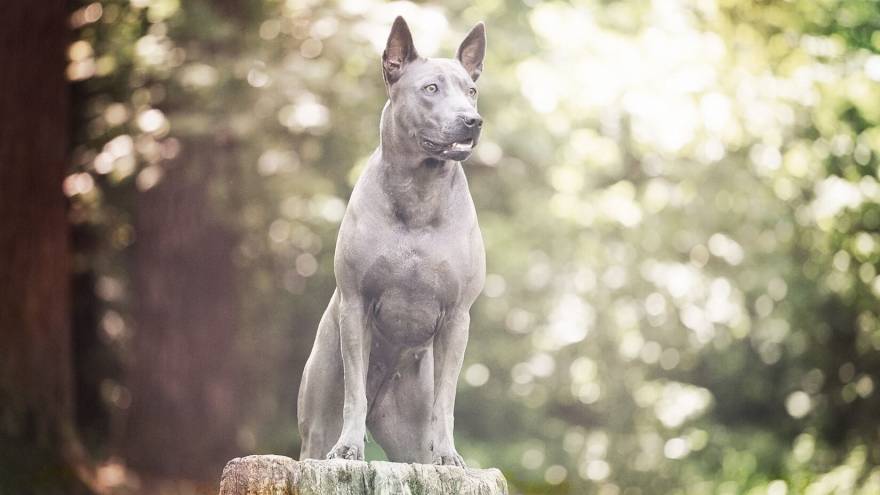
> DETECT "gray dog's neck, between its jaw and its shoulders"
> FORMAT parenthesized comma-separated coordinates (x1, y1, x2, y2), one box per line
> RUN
(379, 103, 459, 228)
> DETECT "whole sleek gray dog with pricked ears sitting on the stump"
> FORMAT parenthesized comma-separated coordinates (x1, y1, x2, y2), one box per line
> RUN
(298, 17, 486, 466)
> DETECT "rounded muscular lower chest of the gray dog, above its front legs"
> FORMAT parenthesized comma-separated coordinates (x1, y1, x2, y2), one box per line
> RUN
(363, 229, 470, 346)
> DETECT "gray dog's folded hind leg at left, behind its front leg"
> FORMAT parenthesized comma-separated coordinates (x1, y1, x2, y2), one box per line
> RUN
(297, 292, 344, 460)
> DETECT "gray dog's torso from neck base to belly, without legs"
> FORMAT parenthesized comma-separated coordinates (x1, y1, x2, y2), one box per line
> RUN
(336, 149, 485, 354)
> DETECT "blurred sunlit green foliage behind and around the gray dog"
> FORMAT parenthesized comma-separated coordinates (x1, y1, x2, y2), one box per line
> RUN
(65, 0, 880, 494)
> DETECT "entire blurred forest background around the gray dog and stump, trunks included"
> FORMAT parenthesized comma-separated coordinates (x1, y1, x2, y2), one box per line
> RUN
(0, 0, 880, 495)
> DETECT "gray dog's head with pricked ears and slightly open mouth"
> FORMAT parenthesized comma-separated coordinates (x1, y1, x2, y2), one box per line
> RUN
(382, 17, 486, 161)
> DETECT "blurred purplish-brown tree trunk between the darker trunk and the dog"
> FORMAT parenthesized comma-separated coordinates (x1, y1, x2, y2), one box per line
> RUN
(125, 140, 242, 479)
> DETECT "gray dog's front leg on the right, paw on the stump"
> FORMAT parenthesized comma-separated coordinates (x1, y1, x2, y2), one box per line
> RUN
(431, 310, 471, 467)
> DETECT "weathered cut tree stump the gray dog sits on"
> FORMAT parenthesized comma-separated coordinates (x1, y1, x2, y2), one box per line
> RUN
(220, 455, 507, 495)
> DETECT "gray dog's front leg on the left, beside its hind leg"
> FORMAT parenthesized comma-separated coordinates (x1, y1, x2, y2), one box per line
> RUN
(327, 295, 371, 460)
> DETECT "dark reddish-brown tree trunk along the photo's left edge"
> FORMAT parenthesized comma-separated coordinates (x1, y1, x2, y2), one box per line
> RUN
(0, 0, 89, 493)
